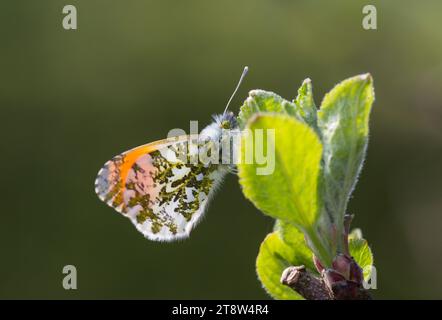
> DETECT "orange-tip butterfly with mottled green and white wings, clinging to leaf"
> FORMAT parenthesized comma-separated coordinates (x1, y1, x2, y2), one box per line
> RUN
(95, 67, 248, 241)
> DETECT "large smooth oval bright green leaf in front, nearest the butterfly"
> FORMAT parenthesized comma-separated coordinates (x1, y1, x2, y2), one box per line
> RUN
(238, 114, 322, 229)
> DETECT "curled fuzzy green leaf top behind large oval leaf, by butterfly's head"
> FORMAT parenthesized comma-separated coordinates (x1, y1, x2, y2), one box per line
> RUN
(238, 90, 296, 129)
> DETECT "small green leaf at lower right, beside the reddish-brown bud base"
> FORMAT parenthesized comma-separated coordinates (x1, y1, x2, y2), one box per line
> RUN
(348, 229, 373, 281)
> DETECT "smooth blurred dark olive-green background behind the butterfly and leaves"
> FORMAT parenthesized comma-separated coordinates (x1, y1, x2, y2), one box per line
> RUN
(0, 0, 442, 299)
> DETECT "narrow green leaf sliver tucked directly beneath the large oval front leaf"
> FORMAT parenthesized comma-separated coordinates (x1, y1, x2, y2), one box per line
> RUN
(275, 220, 316, 272)
